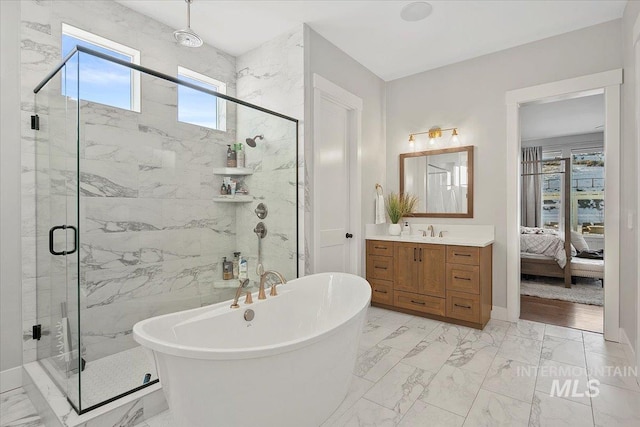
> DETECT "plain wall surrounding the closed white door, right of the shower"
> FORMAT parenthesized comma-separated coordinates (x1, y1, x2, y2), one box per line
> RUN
(305, 27, 388, 274)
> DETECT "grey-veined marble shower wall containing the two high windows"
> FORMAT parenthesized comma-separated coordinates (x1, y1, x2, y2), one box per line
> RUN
(21, 0, 236, 363)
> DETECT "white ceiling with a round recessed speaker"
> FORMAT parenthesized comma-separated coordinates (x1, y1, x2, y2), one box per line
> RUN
(117, 0, 627, 81)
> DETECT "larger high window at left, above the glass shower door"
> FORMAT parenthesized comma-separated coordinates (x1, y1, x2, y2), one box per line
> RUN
(62, 24, 140, 112)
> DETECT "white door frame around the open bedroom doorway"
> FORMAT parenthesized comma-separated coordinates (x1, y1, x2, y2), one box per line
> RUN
(505, 69, 622, 342)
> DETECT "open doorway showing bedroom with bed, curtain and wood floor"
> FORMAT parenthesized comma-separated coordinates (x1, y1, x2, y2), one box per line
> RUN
(520, 91, 606, 333)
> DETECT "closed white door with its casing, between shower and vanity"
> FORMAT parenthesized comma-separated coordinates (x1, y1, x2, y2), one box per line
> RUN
(312, 74, 364, 274)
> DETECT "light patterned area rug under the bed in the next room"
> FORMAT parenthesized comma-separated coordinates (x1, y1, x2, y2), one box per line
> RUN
(520, 277, 604, 306)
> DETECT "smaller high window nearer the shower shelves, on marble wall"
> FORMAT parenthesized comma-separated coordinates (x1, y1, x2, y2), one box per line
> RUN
(178, 67, 227, 131)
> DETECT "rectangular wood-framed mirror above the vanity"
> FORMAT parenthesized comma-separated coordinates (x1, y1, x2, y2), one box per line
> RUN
(400, 146, 473, 218)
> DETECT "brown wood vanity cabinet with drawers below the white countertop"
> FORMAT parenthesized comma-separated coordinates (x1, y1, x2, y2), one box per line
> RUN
(367, 240, 492, 329)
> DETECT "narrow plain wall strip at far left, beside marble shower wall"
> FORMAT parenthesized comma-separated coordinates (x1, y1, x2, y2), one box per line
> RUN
(0, 1, 22, 391)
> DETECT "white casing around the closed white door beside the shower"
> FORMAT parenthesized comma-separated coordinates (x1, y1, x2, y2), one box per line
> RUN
(312, 73, 364, 276)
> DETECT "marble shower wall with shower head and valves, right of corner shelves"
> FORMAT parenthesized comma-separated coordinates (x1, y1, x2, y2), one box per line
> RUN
(236, 27, 304, 279)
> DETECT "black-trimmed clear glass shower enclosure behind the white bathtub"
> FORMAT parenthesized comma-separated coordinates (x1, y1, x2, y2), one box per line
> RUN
(31, 46, 298, 413)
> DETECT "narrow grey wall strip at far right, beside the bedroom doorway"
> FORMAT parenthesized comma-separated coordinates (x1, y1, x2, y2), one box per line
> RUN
(620, 1, 640, 355)
